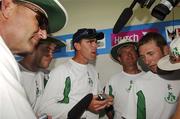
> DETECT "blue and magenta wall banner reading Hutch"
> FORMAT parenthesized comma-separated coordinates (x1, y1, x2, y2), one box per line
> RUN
(46, 20, 180, 58)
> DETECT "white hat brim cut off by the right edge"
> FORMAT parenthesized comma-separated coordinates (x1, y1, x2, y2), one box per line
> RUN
(158, 55, 180, 71)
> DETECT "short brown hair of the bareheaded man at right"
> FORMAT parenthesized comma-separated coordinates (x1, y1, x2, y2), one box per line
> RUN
(138, 32, 167, 52)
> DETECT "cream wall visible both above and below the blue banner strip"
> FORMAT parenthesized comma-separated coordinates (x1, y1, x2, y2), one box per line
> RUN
(51, 0, 180, 87)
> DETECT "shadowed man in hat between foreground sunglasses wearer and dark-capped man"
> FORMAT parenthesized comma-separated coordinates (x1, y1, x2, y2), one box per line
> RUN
(19, 37, 65, 116)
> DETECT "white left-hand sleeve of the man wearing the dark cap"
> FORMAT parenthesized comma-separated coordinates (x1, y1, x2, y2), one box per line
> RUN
(38, 67, 76, 119)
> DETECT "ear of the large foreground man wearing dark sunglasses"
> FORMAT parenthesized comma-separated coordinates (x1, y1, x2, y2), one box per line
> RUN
(1, 0, 15, 18)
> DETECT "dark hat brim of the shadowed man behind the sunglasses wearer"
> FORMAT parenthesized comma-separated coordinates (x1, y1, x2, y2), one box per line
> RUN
(39, 37, 66, 48)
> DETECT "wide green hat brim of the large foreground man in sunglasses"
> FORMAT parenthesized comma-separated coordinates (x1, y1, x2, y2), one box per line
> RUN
(24, 0, 68, 33)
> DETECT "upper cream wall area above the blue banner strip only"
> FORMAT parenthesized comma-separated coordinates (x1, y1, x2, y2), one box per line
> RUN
(54, 0, 180, 35)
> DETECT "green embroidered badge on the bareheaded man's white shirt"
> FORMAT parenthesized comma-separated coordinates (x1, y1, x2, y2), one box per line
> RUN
(164, 84, 177, 104)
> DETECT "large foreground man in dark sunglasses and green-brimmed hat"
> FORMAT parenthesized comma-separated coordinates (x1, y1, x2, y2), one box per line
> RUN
(0, 0, 67, 119)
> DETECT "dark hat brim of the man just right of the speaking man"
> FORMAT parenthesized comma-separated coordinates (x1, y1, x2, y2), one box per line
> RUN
(111, 42, 137, 62)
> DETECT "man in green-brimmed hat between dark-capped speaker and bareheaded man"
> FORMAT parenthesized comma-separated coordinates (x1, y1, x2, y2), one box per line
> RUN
(105, 38, 145, 119)
